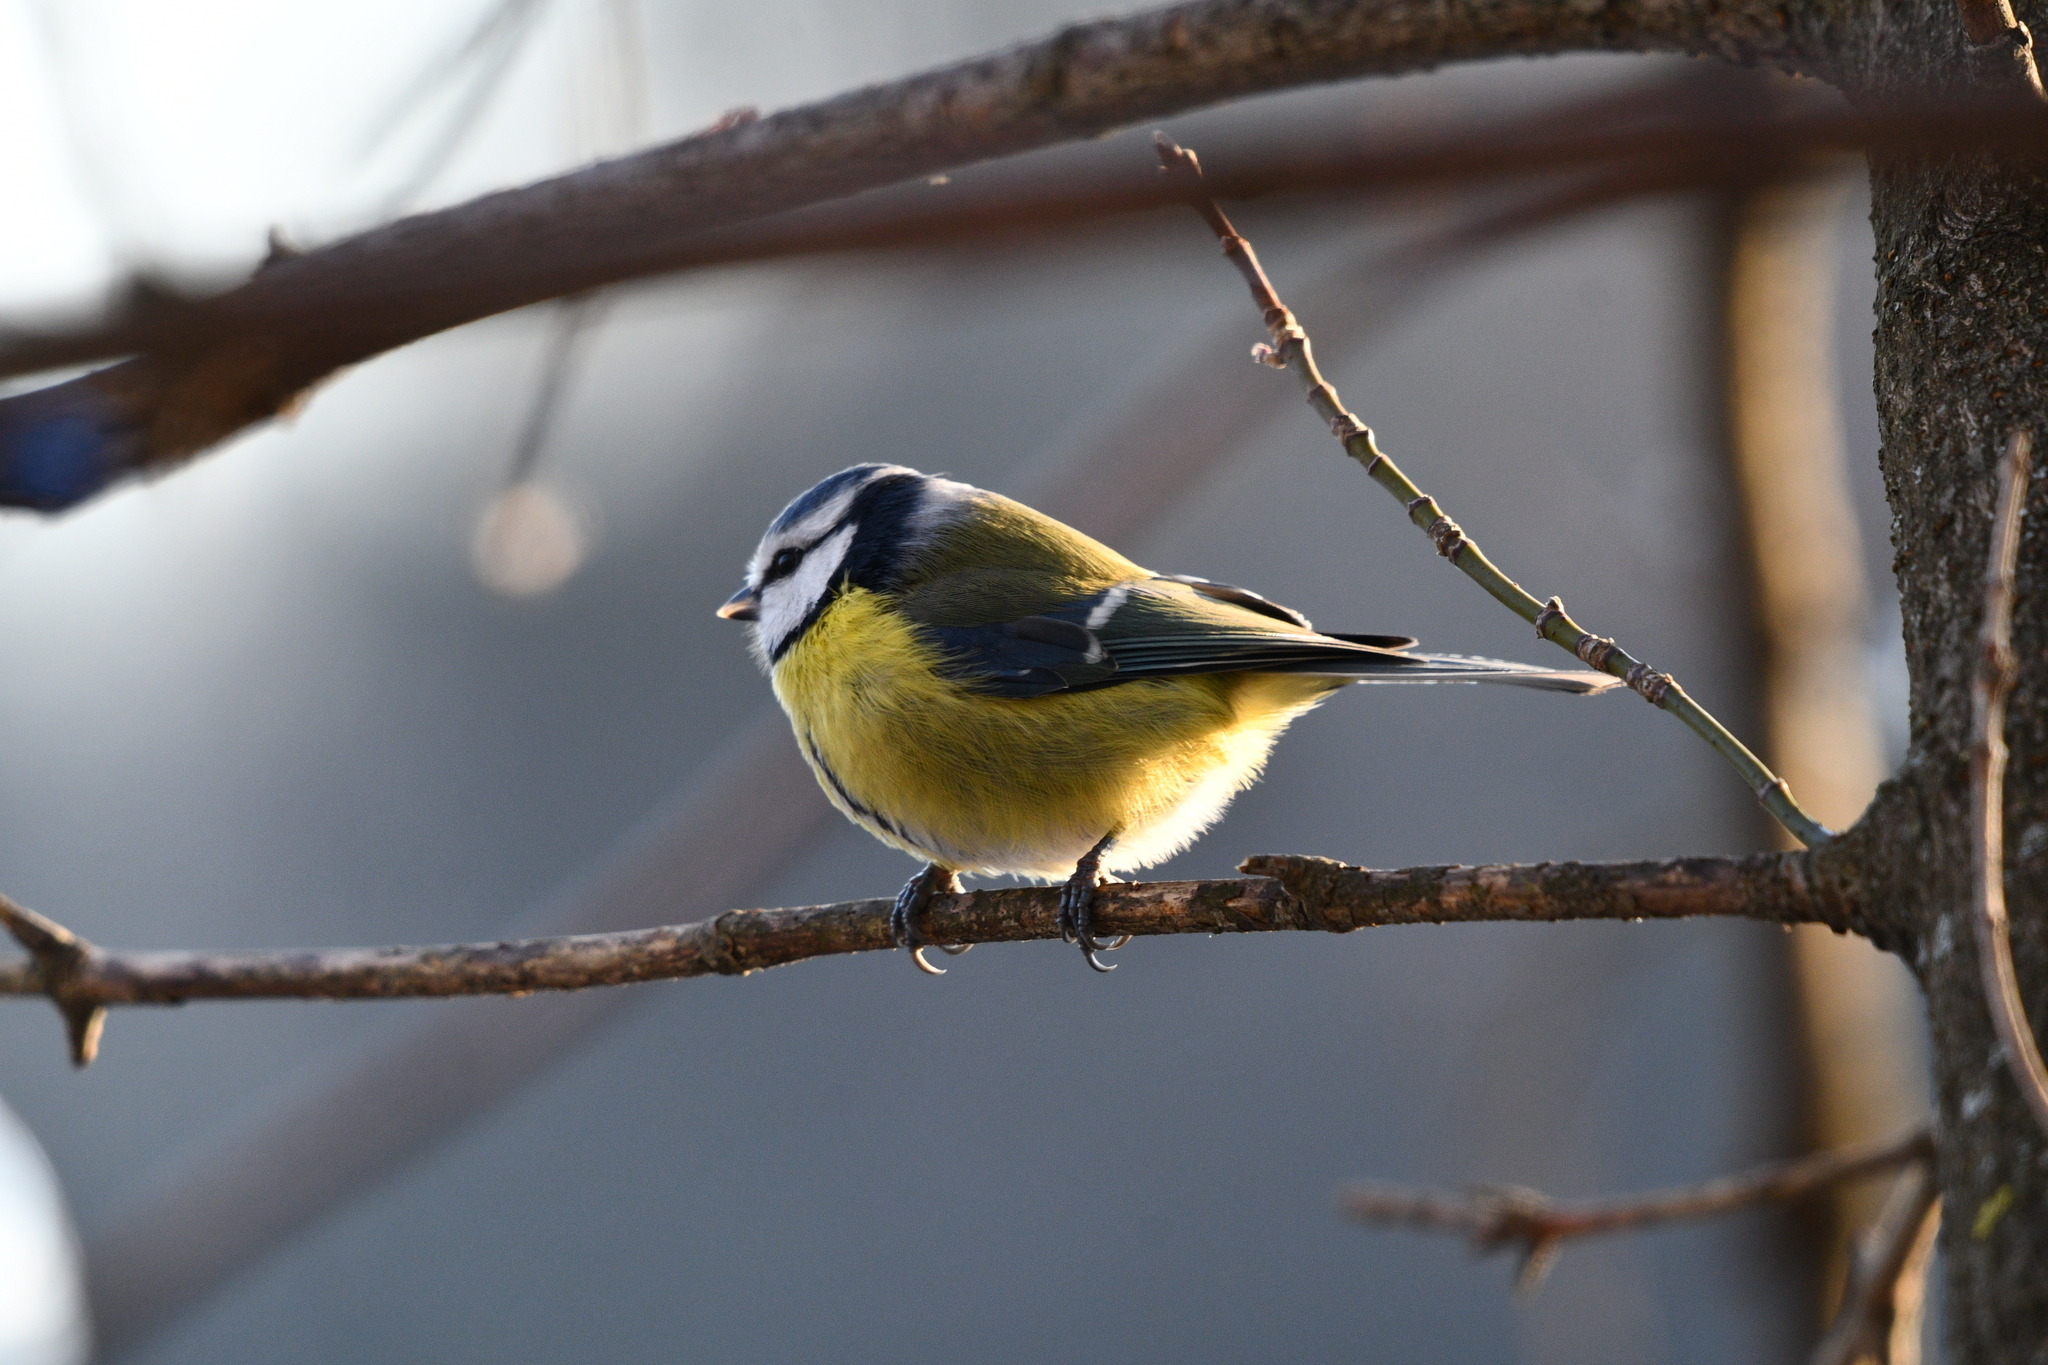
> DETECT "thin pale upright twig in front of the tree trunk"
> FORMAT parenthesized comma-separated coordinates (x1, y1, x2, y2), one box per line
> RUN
(1970, 432, 2048, 1132)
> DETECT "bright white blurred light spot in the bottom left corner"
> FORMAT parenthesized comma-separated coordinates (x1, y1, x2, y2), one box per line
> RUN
(0, 1105, 86, 1365)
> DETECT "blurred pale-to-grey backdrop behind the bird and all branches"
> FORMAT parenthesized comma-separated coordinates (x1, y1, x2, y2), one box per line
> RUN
(0, 0, 1921, 1365)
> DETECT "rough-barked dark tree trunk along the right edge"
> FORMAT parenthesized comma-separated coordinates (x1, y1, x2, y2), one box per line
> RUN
(1860, 0, 2048, 1365)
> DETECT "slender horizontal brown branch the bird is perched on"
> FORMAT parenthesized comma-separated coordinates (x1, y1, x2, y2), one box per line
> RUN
(0, 853, 1860, 1064)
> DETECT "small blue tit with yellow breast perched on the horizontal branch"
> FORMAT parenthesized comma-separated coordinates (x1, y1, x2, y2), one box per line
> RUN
(719, 465, 1618, 974)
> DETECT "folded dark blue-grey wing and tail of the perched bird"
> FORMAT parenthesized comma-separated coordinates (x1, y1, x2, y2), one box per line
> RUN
(926, 577, 1614, 696)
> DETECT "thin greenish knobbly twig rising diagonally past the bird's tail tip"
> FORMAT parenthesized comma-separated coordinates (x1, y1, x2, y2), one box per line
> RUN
(1157, 133, 1833, 847)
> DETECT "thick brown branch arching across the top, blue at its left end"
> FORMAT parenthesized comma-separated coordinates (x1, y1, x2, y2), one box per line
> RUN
(0, 0, 1851, 508)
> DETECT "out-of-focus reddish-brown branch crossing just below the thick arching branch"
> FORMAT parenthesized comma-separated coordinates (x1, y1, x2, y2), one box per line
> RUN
(28, 70, 2048, 388)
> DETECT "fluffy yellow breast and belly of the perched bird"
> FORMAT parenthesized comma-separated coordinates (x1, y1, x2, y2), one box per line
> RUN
(774, 589, 1341, 878)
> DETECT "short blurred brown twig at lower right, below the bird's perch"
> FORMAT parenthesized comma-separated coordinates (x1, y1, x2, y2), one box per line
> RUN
(1343, 1128, 1933, 1291)
